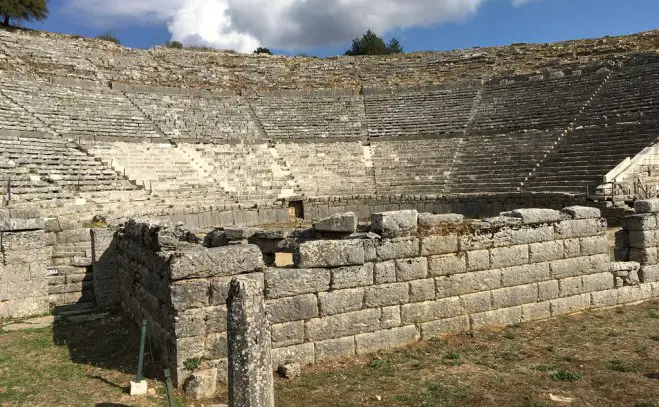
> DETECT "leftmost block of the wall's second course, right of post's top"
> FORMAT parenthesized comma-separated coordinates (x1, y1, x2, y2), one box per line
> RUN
(265, 268, 331, 299)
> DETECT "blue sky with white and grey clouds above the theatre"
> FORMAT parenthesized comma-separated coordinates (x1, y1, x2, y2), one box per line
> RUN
(21, 0, 659, 57)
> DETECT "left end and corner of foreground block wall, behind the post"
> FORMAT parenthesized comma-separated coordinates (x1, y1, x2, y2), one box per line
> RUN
(114, 221, 263, 386)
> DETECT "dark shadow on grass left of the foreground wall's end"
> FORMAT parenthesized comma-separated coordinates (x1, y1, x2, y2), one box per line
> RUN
(53, 309, 161, 382)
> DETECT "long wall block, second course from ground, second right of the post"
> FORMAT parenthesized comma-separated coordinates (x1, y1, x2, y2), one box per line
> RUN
(305, 309, 380, 342)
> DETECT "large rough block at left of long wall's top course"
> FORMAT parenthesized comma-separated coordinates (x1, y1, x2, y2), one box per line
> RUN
(293, 240, 364, 268)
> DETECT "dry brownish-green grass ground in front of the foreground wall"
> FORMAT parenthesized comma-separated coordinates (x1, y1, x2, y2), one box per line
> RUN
(0, 300, 659, 407)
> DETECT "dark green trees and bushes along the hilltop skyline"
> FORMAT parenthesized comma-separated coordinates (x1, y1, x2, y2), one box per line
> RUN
(0, 0, 403, 56)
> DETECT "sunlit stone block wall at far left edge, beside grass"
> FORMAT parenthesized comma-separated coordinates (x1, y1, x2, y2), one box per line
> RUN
(0, 215, 50, 318)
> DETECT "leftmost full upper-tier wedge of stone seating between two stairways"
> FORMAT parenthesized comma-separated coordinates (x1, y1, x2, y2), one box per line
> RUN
(0, 75, 161, 140)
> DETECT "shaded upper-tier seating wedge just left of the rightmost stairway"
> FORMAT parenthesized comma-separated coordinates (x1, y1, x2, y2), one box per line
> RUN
(472, 67, 608, 134)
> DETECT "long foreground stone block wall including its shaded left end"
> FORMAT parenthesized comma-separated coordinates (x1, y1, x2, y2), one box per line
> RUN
(108, 203, 659, 398)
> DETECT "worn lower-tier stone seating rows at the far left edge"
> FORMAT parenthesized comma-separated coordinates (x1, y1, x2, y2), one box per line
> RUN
(0, 137, 136, 201)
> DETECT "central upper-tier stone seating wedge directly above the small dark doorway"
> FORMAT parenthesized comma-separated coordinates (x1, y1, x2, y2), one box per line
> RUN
(249, 91, 366, 141)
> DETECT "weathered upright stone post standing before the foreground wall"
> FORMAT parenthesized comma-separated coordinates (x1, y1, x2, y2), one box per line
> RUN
(227, 278, 275, 407)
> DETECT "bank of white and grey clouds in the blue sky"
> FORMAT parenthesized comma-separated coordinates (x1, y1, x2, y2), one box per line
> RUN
(65, 0, 528, 52)
